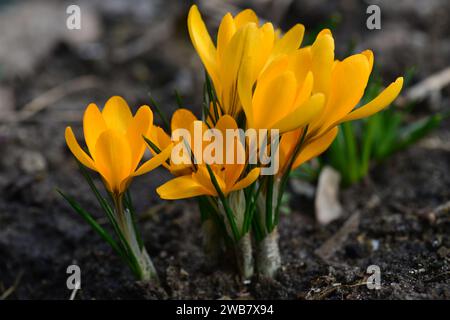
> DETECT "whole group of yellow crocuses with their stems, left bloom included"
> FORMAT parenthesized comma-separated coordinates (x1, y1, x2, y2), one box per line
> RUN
(66, 5, 403, 278)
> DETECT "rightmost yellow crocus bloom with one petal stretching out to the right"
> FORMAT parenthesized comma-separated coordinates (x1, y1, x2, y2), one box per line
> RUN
(302, 29, 403, 139)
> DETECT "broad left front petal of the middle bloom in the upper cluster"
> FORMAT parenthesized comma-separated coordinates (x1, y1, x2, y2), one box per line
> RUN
(253, 71, 297, 129)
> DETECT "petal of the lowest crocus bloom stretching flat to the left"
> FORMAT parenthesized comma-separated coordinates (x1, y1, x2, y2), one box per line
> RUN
(156, 176, 210, 200)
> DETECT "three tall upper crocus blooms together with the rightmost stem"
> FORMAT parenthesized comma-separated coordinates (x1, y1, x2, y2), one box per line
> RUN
(178, 6, 403, 276)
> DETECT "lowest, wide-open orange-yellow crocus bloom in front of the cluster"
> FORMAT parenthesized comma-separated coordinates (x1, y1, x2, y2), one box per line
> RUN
(156, 115, 260, 200)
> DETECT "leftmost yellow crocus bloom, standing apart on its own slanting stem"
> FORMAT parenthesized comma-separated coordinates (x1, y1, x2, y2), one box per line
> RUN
(65, 96, 171, 195)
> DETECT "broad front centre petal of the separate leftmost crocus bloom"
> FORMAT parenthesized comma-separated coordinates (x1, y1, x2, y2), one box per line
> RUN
(93, 129, 131, 193)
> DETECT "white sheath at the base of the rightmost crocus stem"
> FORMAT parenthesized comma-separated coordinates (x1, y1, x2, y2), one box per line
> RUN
(256, 227, 281, 278)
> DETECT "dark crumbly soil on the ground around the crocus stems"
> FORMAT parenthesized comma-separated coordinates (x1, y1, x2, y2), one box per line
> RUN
(0, 131, 450, 299)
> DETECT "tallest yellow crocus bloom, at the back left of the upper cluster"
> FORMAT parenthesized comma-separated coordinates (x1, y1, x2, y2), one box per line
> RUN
(188, 5, 304, 117)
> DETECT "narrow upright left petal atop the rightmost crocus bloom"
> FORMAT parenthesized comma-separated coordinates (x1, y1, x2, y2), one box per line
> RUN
(311, 31, 334, 95)
